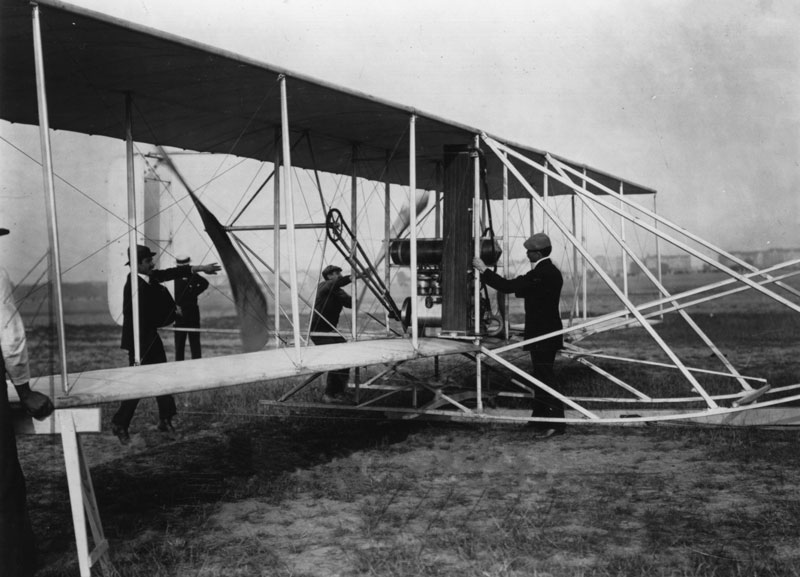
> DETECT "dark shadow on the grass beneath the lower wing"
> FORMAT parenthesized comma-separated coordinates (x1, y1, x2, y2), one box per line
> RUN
(28, 419, 418, 577)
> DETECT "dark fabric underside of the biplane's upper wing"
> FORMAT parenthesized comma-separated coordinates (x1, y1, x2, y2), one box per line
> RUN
(0, 0, 654, 198)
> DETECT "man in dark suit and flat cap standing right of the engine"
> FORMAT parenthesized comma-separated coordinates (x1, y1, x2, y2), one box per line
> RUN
(472, 232, 565, 438)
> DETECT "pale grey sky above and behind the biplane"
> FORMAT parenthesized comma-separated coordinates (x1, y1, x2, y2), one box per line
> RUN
(0, 0, 800, 281)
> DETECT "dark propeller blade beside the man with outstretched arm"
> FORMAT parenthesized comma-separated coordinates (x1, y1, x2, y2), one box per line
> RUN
(189, 191, 269, 353)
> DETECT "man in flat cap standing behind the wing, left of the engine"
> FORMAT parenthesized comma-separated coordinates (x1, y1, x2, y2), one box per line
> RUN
(311, 264, 353, 404)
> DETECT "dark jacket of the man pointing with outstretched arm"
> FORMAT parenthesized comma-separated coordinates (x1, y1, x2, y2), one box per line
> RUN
(120, 265, 192, 364)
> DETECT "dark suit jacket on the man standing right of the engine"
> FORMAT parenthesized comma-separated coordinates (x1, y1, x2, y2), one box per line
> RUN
(481, 258, 564, 350)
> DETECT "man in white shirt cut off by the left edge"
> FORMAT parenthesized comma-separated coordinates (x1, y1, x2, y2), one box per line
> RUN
(0, 228, 53, 577)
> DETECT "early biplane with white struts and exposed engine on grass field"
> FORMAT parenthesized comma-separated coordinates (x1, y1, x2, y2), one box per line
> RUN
(0, 0, 800, 575)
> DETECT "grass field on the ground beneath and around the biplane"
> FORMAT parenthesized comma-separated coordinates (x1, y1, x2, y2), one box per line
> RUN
(12, 272, 800, 577)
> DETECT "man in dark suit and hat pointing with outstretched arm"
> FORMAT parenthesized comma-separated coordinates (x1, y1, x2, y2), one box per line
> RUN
(111, 245, 220, 445)
